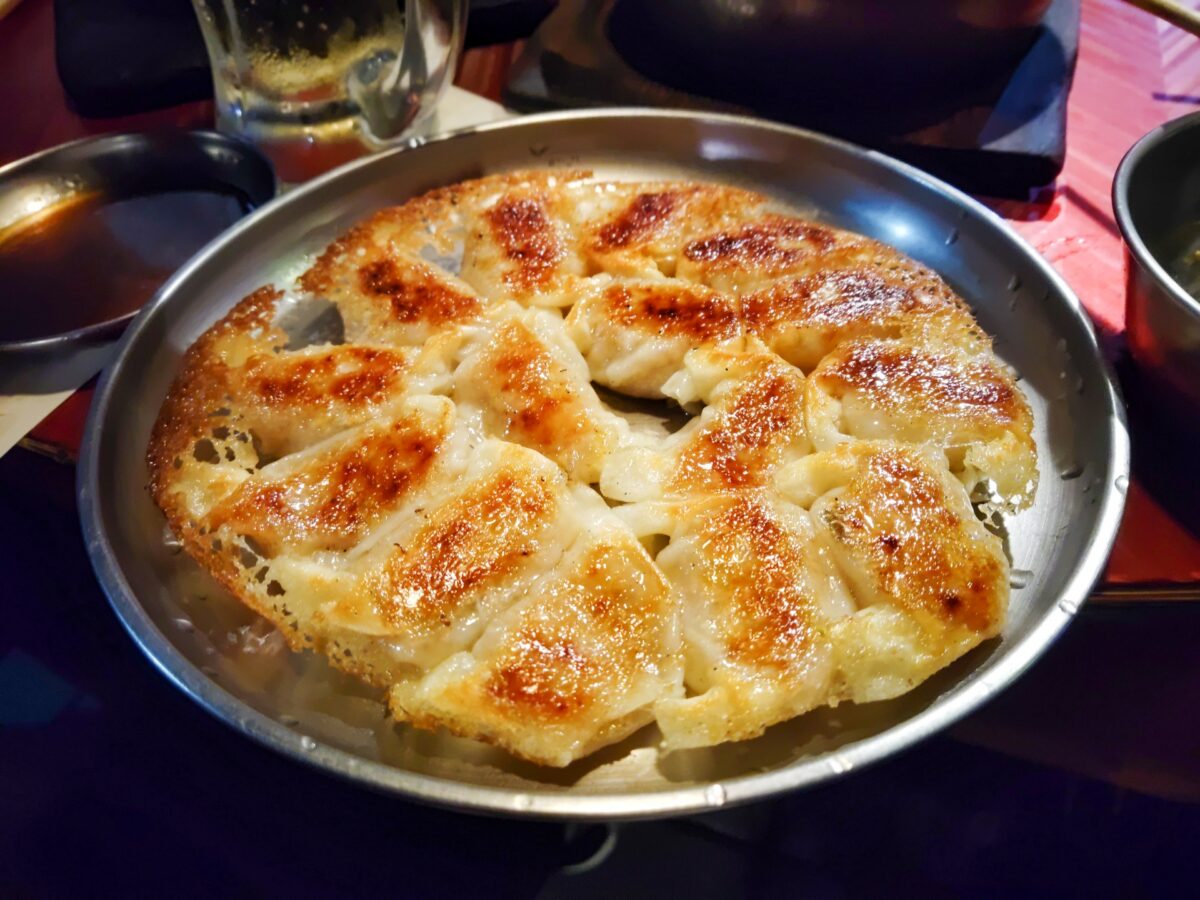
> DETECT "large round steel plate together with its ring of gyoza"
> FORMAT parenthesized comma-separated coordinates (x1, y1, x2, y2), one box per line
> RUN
(79, 110, 1128, 818)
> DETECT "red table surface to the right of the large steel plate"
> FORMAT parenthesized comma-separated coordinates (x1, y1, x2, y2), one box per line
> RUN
(991, 0, 1200, 588)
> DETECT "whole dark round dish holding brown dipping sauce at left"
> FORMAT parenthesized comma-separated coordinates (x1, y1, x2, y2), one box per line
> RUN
(0, 131, 276, 361)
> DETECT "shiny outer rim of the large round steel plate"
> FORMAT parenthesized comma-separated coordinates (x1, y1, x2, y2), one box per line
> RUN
(77, 107, 1129, 821)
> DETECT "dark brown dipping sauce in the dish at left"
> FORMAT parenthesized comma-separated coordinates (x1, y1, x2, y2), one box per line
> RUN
(0, 190, 250, 342)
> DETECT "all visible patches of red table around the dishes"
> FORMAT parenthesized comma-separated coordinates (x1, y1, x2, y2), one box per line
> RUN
(0, 0, 1200, 599)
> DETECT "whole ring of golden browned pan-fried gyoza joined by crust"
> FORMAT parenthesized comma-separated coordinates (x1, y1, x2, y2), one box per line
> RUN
(146, 170, 1037, 766)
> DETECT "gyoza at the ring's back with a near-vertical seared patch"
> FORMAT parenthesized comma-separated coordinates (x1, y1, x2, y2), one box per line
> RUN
(461, 173, 588, 306)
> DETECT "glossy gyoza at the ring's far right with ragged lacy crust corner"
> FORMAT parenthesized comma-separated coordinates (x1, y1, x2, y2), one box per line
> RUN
(805, 341, 1038, 509)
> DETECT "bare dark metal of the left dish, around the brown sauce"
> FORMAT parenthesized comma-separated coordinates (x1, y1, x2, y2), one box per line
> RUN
(0, 131, 276, 364)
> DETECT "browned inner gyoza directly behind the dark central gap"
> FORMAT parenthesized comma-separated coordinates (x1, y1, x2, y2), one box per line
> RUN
(566, 278, 743, 397)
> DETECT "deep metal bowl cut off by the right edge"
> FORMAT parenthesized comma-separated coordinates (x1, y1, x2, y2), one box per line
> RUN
(1112, 113, 1200, 419)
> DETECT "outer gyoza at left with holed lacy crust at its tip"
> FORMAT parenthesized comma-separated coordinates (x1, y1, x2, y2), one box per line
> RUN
(160, 397, 470, 672)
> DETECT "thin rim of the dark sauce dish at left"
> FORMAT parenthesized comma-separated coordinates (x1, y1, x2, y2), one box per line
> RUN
(0, 128, 278, 355)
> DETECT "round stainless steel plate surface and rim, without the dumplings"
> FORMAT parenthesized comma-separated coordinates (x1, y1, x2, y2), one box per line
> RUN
(78, 109, 1129, 818)
